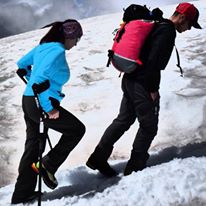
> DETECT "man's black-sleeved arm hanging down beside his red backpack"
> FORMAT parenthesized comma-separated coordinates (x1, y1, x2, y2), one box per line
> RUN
(145, 23, 176, 92)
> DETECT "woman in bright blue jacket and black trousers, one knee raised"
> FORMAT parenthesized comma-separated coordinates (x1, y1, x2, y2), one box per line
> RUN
(12, 19, 85, 204)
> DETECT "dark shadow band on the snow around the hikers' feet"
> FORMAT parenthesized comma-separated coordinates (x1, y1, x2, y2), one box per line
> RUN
(42, 142, 206, 201)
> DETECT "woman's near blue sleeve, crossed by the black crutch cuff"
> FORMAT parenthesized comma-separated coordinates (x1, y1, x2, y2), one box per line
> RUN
(34, 49, 65, 112)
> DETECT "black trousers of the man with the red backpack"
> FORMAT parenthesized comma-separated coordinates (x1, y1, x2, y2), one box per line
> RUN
(98, 77, 159, 161)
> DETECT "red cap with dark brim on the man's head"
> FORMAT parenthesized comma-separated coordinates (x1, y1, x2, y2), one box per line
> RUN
(175, 2, 202, 29)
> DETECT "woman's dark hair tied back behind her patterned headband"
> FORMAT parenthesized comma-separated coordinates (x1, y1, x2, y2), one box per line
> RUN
(40, 19, 77, 44)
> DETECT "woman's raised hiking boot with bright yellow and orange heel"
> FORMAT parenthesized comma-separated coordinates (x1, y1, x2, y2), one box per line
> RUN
(32, 162, 58, 190)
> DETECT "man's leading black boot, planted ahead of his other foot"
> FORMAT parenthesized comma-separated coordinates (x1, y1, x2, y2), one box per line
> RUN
(124, 160, 146, 176)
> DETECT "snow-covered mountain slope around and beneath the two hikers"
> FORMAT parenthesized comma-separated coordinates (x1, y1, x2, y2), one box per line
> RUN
(0, 0, 206, 206)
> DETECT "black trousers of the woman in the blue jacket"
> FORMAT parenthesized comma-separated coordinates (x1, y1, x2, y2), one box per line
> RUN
(13, 96, 85, 199)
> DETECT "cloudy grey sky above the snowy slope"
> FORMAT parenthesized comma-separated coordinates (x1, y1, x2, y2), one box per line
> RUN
(0, 0, 198, 38)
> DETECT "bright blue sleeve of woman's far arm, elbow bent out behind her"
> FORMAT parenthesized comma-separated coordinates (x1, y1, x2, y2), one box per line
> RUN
(17, 47, 36, 81)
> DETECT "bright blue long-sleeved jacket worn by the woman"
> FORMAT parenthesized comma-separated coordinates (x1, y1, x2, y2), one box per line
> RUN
(17, 42, 70, 112)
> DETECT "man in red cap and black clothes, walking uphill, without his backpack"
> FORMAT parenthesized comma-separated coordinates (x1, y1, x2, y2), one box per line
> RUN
(86, 3, 201, 176)
